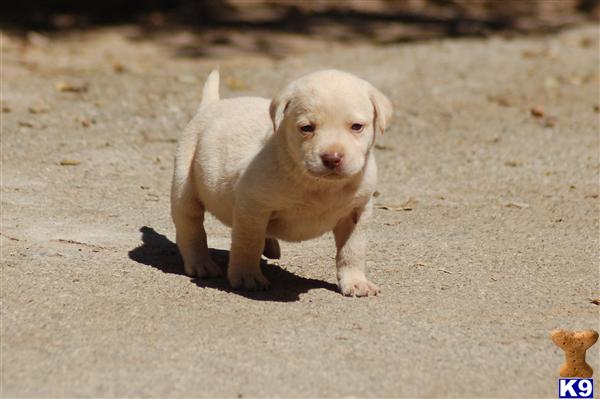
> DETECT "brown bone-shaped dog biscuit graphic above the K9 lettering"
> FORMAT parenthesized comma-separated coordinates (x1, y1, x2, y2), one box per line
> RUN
(550, 330, 598, 378)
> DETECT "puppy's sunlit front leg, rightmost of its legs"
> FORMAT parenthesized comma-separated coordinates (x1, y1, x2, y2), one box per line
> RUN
(333, 201, 379, 296)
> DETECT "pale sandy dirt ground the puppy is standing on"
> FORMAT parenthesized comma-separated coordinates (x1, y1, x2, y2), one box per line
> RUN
(0, 26, 600, 398)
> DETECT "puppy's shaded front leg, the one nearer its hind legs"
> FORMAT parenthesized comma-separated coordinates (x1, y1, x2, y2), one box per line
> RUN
(227, 205, 270, 291)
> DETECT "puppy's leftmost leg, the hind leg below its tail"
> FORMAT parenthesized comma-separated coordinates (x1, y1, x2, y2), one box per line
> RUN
(172, 199, 223, 278)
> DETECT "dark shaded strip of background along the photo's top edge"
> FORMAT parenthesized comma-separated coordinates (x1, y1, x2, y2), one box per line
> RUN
(0, 0, 600, 40)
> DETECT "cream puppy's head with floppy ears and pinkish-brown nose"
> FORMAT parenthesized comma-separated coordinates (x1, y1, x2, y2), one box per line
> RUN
(270, 70, 392, 179)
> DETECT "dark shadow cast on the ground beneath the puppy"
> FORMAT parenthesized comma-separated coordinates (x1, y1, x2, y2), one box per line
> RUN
(129, 226, 338, 302)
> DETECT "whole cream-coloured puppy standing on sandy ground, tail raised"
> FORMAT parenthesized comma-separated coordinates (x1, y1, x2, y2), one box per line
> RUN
(171, 70, 392, 296)
